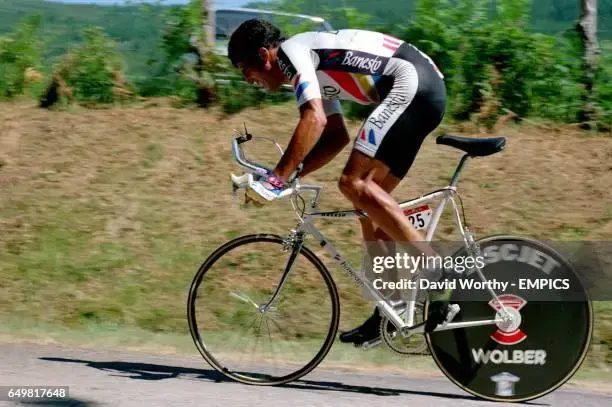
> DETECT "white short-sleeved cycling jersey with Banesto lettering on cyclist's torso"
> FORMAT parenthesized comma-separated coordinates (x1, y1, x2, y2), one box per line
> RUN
(278, 29, 443, 115)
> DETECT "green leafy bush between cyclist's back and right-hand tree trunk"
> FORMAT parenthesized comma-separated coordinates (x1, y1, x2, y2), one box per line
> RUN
(395, 0, 608, 126)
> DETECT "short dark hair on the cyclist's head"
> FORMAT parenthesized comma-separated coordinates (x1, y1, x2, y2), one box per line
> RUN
(227, 18, 285, 66)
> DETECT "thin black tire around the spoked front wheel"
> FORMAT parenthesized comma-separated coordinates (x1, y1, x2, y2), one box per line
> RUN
(187, 234, 340, 386)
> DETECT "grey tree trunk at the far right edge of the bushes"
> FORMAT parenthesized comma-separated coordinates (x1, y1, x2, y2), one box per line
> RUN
(576, 0, 599, 129)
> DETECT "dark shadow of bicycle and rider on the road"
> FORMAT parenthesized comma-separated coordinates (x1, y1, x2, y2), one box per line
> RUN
(40, 357, 545, 405)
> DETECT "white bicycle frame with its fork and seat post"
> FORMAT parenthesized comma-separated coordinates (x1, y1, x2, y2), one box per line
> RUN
(233, 134, 509, 335)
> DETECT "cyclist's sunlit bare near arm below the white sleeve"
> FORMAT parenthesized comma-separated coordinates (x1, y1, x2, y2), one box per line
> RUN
(273, 99, 327, 181)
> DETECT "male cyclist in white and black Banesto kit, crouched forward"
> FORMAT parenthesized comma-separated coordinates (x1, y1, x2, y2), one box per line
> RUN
(228, 19, 446, 344)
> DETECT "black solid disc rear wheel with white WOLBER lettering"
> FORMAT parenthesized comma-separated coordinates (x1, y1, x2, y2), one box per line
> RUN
(425, 236, 593, 402)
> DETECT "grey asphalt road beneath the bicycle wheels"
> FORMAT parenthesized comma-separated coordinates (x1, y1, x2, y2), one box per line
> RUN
(0, 345, 612, 407)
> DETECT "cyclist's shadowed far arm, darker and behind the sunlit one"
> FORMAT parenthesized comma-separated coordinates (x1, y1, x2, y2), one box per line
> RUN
(300, 114, 350, 177)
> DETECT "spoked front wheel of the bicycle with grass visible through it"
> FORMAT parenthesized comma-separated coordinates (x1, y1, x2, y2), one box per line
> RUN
(187, 234, 340, 385)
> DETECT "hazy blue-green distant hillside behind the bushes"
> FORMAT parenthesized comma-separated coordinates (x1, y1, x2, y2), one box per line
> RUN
(0, 0, 612, 83)
